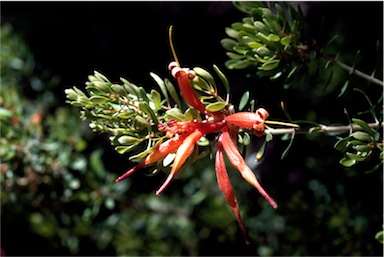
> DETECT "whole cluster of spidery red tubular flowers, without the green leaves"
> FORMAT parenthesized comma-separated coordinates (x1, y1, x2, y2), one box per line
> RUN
(116, 58, 277, 243)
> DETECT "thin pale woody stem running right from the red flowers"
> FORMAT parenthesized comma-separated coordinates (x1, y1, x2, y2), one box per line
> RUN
(265, 122, 384, 135)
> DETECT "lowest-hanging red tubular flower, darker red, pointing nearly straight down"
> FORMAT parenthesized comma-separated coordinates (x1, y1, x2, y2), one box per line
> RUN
(215, 136, 250, 244)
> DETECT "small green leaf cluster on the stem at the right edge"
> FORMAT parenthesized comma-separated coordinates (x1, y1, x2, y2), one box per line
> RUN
(335, 119, 384, 170)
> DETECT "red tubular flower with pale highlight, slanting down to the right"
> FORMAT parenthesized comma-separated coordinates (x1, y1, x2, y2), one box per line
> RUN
(221, 127, 277, 208)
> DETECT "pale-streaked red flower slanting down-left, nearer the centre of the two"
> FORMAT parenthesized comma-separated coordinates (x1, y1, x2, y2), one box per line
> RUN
(156, 130, 204, 195)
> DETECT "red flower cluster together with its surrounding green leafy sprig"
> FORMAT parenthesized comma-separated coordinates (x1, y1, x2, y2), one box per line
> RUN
(66, 27, 296, 243)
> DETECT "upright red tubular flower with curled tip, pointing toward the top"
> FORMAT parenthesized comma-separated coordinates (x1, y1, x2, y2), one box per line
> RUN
(168, 62, 206, 113)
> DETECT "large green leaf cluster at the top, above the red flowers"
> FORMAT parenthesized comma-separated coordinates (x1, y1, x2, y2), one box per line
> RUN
(221, 1, 309, 79)
